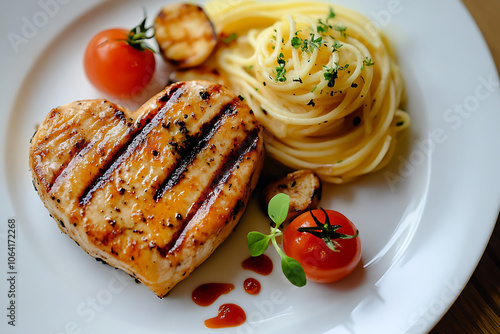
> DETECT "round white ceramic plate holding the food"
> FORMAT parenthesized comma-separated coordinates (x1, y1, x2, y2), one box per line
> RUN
(0, 0, 500, 334)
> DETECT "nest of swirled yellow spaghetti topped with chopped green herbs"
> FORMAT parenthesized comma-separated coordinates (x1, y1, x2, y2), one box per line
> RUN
(206, 0, 409, 183)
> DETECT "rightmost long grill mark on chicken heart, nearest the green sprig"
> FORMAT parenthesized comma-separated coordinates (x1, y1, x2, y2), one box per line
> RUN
(156, 128, 259, 257)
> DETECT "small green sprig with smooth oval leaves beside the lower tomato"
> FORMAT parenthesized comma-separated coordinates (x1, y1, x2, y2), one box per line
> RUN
(247, 193, 307, 287)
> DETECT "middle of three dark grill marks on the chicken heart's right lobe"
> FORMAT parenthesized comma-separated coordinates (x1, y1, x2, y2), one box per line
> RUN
(153, 99, 237, 202)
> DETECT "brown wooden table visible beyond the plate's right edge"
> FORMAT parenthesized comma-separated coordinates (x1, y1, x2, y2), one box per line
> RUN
(431, 0, 500, 334)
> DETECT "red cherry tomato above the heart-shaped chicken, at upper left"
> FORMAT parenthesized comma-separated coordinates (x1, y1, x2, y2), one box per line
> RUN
(84, 19, 156, 98)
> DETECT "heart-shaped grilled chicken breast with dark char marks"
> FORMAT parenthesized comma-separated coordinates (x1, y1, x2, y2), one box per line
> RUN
(30, 81, 264, 297)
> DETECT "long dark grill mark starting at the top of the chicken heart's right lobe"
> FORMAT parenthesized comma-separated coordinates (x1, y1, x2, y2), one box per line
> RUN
(79, 85, 183, 206)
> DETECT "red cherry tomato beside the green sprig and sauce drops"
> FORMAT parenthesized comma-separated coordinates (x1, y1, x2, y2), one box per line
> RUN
(283, 209, 361, 283)
